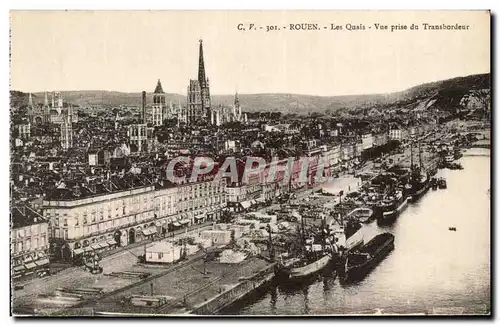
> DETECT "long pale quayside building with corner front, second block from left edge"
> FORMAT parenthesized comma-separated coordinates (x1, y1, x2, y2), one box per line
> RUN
(42, 175, 155, 260)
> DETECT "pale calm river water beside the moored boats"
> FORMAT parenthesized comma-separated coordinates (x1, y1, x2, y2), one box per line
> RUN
(222, 149, 491, 315)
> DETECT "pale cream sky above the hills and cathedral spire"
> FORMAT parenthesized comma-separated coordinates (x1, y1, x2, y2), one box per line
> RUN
(10, 11, 490, 96)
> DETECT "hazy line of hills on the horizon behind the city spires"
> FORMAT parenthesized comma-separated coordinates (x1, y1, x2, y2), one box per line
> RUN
(10, 74, 490, 114)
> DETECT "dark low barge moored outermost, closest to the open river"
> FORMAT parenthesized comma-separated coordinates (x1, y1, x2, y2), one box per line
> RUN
(340, 233, 394, 283)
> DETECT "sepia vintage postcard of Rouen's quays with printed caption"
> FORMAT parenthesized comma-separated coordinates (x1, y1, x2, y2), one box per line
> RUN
(10, 10, 492, 317)
